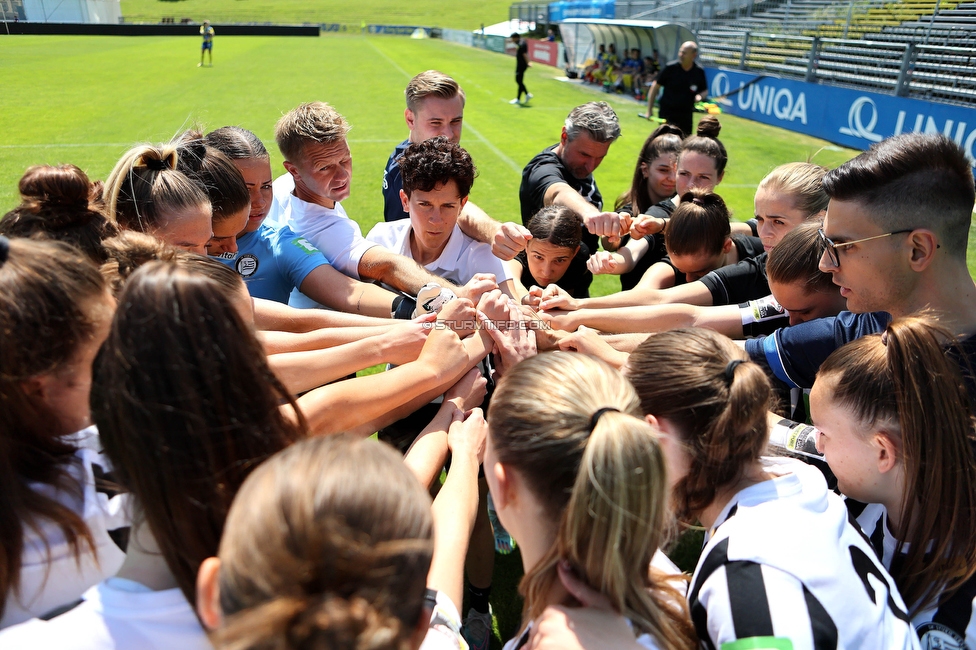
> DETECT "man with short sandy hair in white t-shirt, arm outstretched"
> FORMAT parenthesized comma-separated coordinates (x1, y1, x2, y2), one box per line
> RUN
(269, 102, 495, 308)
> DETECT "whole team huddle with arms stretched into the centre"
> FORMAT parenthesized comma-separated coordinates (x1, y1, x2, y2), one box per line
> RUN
(0, 64, 976, 650)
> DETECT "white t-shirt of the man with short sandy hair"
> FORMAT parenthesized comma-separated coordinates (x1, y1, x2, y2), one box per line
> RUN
(266, 174, 376, 280)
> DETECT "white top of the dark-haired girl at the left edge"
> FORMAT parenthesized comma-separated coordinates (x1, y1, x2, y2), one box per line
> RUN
(0, 427, 131, 624)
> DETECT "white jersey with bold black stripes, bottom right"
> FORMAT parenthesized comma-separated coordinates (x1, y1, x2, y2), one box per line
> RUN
(688, 458, 919, 650)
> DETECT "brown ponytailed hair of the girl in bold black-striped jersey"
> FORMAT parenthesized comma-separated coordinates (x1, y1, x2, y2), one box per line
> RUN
(627, 329, 772, 521)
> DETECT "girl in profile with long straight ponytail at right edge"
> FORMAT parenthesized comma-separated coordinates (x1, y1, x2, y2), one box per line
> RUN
(810, 318, 976, 648)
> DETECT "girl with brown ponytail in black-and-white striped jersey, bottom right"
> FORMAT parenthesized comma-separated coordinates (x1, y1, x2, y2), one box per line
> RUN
(627, 329, 918, 650)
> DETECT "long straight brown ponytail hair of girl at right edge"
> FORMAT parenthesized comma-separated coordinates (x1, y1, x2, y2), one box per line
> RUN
(817, 317, 976, 615)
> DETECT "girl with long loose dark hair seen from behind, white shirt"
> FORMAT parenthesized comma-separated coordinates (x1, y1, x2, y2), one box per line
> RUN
(0, 262, 305, 650)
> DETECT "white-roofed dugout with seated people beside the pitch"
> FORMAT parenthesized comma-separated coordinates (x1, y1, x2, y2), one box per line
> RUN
(558, 18, 695, 73)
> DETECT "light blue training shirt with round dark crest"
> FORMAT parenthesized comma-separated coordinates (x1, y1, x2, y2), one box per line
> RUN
(216, 223, 329, 304)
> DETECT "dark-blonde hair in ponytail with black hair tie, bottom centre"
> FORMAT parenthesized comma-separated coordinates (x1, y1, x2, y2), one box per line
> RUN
(489, 352, 695, 648)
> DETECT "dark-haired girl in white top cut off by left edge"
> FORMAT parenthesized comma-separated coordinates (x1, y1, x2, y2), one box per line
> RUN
(0, 238, 128, 628)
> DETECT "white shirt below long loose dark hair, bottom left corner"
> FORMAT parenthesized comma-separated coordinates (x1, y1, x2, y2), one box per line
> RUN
(0, 578, 213, 650)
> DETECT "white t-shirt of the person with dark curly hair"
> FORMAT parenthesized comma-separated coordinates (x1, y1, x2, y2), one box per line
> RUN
(366, 219, 512, 285)
